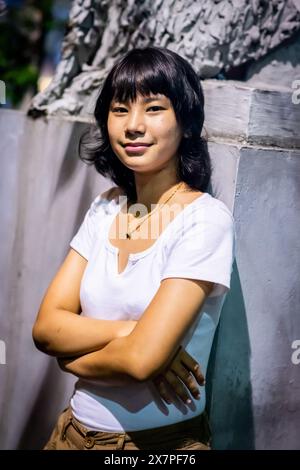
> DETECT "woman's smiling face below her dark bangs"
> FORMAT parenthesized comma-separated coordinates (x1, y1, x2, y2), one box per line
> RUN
(107, 94, 182, 172)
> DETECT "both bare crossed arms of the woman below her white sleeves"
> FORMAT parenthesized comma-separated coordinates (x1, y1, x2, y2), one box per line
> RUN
(33, 249, 212, 400)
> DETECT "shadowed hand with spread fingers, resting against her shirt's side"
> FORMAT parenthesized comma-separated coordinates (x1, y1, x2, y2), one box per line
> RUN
(153, 347, 205, 404)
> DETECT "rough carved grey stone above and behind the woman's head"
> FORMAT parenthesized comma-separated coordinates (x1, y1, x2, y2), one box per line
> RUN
(30, 0, 300, 115)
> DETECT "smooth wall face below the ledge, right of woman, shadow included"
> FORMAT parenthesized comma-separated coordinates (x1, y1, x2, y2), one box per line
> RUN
(206, 144, 300, 449)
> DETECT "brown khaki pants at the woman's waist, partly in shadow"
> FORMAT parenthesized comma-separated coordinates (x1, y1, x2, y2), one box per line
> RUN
(44, 407, 211, 450)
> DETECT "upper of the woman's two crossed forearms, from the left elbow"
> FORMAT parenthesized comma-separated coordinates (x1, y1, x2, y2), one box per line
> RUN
(33, 309, 136, 357)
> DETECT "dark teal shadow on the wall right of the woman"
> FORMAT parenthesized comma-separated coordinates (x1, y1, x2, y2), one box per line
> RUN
(207, 261, 255, 450)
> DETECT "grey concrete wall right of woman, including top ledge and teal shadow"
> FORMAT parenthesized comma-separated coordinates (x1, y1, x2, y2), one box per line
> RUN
(204, 80, 300, 449)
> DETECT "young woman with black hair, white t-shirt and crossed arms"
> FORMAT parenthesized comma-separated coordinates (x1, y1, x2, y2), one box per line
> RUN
(33, 47, 234, 450)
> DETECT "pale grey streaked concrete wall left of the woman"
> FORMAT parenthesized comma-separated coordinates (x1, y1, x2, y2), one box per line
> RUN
(0, 110, 111, 449)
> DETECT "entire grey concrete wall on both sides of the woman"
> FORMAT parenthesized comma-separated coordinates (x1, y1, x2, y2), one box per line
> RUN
(0, 80, 300, 449)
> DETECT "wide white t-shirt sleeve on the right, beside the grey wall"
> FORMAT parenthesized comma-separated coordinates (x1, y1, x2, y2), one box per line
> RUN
(162, 208, 235, 297)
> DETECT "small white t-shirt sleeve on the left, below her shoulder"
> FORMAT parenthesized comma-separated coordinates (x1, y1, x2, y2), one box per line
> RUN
(70, 195, 101, 260)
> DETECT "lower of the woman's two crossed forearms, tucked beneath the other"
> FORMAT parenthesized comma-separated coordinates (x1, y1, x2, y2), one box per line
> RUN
(58, 338, 138, 386)
